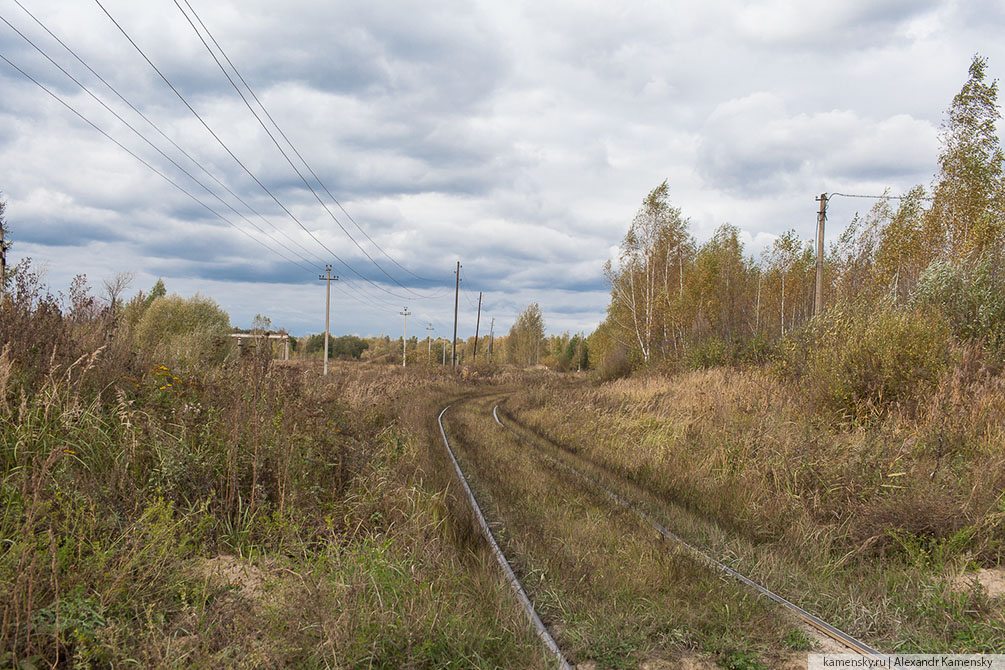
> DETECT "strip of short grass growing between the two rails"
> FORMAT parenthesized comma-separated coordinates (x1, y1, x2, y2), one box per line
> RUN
(446, 397, 812, 669)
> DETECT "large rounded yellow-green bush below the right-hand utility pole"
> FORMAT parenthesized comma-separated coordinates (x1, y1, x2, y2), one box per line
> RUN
(779, 302, 952, 421)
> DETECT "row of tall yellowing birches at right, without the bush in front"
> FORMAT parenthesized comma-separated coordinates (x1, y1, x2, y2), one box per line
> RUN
(590, 56, 1005, 372)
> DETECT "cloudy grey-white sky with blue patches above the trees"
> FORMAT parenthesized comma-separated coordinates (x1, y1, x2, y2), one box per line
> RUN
(0, 0, 1005, 337)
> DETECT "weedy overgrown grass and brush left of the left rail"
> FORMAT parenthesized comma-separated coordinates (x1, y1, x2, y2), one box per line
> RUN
(0, 271, 545, 668)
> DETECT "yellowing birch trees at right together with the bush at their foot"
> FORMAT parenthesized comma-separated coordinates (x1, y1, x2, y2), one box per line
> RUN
(589, 56, 1005, 393)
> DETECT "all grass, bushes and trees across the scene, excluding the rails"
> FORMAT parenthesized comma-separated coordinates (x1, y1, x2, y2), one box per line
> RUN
(0, 52, 1005, 668)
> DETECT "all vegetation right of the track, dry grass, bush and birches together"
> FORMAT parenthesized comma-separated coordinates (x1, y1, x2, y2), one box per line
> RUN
(484, 56, 1005, 652)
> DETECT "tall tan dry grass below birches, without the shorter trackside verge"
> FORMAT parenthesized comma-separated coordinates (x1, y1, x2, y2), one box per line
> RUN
(508, 361, 1005, 566)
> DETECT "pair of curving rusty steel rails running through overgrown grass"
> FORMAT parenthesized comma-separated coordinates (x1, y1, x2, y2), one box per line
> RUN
(438, 395, 880, 668)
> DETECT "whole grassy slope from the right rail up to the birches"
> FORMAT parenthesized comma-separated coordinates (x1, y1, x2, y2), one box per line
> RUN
(504, 359, 1005, 652)
